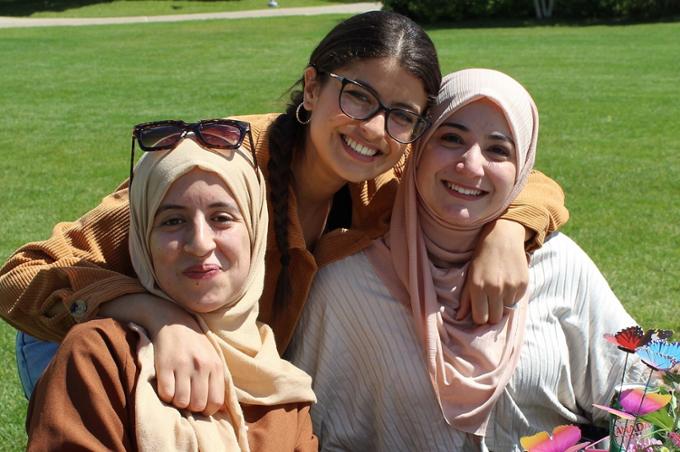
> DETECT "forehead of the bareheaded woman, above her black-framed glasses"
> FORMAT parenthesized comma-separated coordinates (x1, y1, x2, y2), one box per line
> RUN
(334, 58, 427, 110)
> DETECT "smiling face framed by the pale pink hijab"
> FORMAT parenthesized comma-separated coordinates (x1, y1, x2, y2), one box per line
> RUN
(416, 99, 517, 226)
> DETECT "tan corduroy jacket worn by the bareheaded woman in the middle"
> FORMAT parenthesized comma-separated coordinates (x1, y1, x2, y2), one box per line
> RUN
(0, 114, 569, 352)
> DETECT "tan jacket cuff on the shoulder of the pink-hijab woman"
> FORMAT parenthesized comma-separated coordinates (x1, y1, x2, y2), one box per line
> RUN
(501, 171, 569, 251)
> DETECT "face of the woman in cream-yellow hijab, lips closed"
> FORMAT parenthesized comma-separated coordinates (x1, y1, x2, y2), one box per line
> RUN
(149, 169, 250, 313)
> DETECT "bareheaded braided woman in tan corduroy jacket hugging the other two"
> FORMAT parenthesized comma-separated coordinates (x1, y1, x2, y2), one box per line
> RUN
(0, 12, 568, 414)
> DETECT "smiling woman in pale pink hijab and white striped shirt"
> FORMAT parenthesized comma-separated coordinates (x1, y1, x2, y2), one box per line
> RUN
(287, 69, 634, 451)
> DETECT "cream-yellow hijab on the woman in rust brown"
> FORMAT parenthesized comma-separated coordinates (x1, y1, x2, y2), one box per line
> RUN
(130, 139, 316, 451)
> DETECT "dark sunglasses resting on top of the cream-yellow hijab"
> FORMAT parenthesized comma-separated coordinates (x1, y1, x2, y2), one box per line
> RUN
(130, 119, 260, 185)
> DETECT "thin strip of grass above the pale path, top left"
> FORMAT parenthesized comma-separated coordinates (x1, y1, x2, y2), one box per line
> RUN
(0, 0, 368, 18)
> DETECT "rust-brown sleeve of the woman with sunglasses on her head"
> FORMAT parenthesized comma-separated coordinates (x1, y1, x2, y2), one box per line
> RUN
(26, 319, 138, 452)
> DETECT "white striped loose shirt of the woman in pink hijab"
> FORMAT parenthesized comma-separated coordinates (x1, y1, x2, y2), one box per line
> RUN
(287, 234, 640, 452)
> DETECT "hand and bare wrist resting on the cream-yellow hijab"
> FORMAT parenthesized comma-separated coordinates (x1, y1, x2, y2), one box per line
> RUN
(99, 294, 225, 415)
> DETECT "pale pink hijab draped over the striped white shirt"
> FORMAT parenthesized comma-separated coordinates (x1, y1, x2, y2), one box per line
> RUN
(368, 69, 538, 436)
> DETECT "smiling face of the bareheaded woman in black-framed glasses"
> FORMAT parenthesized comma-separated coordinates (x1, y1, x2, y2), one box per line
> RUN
(304, 58, 427, 184)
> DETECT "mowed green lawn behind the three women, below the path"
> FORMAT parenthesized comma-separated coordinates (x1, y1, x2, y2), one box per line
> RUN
(0, 13, 680, 450)
